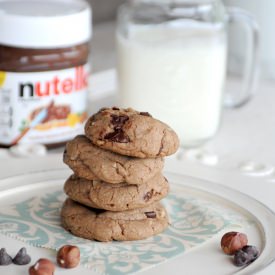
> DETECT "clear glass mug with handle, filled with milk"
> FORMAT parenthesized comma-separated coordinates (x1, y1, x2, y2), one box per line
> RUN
(116, 0, 258, 147)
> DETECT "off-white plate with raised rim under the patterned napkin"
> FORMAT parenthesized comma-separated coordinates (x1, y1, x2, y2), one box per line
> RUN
(0, 169, 275, 275)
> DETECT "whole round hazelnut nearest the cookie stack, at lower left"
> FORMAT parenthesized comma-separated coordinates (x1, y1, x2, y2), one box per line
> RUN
(56, 245, 80, 268)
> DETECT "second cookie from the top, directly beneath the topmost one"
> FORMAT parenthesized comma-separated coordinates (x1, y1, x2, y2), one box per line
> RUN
(63, 136, 164, 184)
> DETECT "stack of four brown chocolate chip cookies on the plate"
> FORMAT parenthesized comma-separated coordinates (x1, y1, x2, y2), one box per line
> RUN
(61, 107, 179, 241)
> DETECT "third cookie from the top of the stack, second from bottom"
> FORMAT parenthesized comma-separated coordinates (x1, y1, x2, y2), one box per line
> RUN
(64, 174, 169, 211)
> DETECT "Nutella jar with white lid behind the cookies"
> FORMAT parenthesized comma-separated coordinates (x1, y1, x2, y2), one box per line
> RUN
(0, 0, 92, 147)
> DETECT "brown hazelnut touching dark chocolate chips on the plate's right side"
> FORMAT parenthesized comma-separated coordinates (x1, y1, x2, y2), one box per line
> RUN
(221, 232, 248, 255)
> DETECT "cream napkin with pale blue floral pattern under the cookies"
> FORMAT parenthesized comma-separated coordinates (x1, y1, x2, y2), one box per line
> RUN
(0, 186, 247, 275)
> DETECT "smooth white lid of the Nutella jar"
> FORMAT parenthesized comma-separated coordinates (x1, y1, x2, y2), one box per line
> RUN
(0, 0, 92, 49)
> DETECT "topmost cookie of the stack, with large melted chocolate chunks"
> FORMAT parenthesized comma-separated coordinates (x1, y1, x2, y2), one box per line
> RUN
(85, 107, 179, 158)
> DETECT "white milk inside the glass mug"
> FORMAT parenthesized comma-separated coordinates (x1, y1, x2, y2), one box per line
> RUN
(117, 22, 226, 146)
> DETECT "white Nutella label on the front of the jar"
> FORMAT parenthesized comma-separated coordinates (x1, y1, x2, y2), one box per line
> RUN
(0, 65, 89, 145)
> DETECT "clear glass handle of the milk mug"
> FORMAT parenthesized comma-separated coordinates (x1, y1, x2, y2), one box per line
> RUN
(224, 7, 259, 108)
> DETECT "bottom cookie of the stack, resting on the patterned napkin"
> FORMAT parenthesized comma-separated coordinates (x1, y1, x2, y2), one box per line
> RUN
(61, 199, 168, 242)
